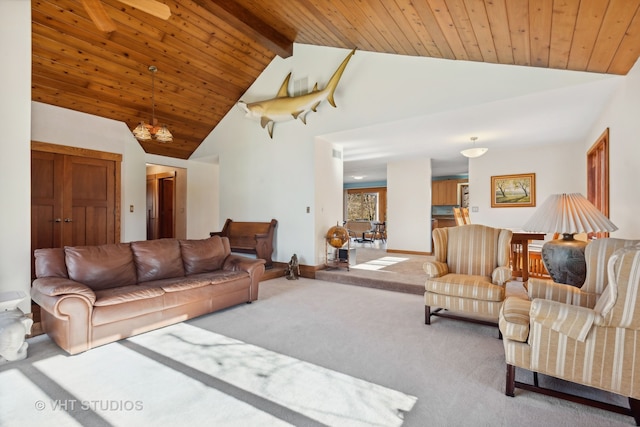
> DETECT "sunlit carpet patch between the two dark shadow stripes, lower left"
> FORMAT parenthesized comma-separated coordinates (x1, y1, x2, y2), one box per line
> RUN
(26, 343, 290, 427)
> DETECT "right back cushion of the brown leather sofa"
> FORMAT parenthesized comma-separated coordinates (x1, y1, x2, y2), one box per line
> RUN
(180, 236, 230, 274)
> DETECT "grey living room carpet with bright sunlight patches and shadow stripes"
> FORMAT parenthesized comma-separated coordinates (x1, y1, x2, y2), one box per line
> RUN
(0, 278, 634, 426)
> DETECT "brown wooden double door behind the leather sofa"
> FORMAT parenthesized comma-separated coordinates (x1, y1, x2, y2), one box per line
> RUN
(31, 143, 121, 274)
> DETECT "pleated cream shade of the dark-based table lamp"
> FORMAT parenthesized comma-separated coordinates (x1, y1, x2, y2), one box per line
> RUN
(522, 193, 618, 234)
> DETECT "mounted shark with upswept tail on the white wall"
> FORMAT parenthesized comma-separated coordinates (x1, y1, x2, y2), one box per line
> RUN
(238, 49, 356, 138)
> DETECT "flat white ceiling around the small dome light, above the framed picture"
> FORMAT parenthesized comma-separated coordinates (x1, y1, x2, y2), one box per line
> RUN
(322, 78, 619, 183)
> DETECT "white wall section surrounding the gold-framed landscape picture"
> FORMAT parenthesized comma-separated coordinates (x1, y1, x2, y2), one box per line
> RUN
(469, 142, 587, 229)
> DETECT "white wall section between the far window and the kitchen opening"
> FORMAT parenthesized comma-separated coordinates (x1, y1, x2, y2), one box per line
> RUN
(387, 159, 431, 253)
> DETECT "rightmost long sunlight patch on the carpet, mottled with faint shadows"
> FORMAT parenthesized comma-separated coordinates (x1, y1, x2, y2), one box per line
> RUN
(129, 323, 417, 427)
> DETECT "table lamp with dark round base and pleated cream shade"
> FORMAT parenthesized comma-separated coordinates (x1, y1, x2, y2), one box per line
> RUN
(523, 193, 618, 287)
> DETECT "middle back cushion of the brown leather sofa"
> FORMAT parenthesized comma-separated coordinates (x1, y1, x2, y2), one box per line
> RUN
(131, 239, 184, 283)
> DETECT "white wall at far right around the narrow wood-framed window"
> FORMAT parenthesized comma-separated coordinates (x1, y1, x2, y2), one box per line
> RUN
(582, 57, 640, 239)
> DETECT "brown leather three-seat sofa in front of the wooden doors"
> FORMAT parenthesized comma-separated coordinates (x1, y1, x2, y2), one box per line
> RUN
(31, 236, 265, 354)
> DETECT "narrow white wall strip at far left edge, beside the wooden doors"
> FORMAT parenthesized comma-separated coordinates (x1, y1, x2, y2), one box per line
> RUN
(0, 0, 31, 313)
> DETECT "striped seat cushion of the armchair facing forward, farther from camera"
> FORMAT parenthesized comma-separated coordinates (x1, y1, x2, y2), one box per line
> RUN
(425, 274, 505, 302)
